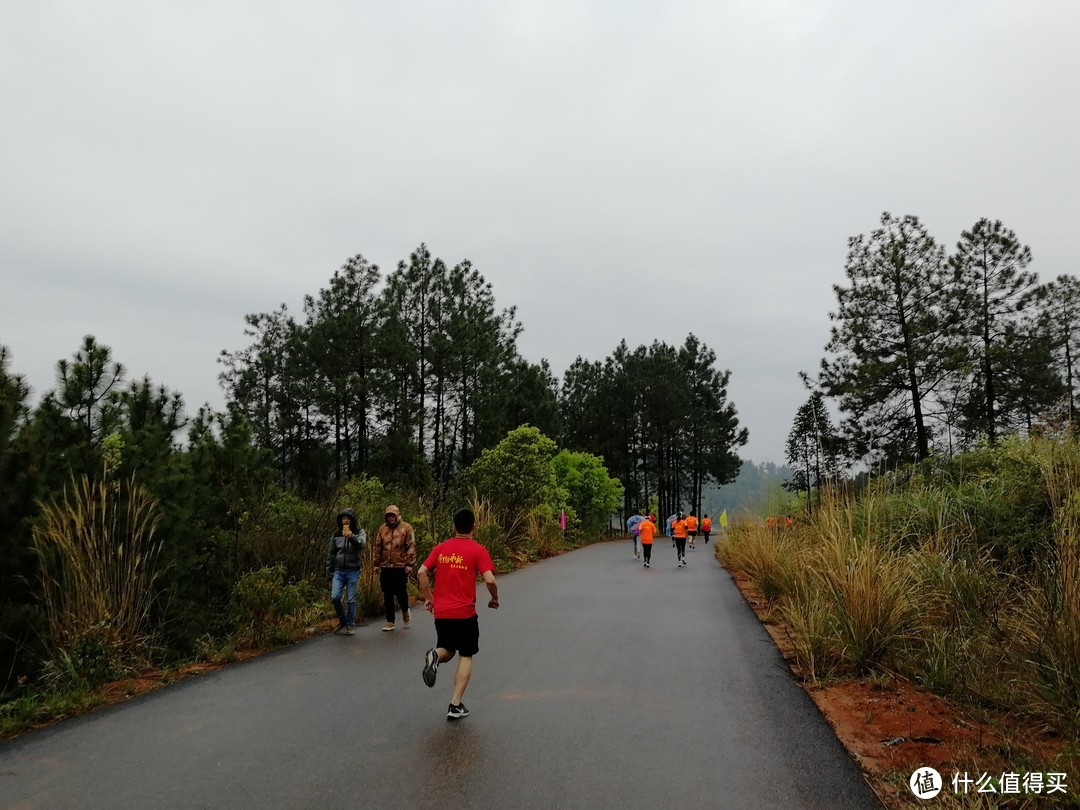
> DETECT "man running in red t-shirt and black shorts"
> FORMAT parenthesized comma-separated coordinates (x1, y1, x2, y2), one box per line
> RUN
(417, 509, 499, 720)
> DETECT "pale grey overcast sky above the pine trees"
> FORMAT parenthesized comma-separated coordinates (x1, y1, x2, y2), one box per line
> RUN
(0, 0, 1080, 462)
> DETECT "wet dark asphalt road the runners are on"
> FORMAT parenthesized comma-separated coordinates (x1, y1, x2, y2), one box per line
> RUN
(0, 539, 879, 810)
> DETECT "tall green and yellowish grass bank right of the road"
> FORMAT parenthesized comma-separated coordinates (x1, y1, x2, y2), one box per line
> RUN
(717, 438, 1080, 741)
